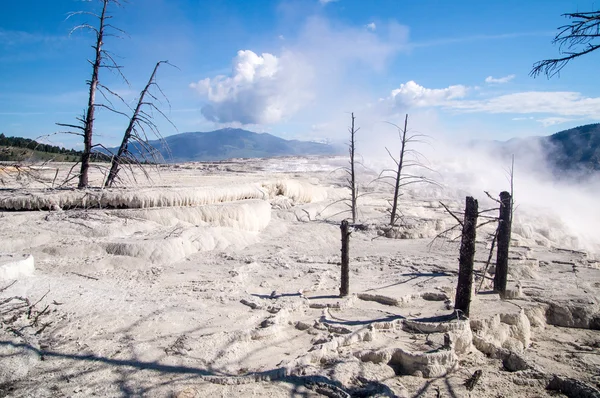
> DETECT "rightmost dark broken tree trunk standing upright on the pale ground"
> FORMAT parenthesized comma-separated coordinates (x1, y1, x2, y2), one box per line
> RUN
(494, 191, 512, 296)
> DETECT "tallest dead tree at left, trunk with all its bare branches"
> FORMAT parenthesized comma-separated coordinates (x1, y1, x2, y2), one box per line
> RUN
(57, 0, 127, 189)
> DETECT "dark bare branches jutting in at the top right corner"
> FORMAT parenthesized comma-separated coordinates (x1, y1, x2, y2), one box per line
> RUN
(530, 11, 600, 78)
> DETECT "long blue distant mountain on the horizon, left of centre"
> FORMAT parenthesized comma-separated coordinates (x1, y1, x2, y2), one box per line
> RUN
(112, 128, 340, 162)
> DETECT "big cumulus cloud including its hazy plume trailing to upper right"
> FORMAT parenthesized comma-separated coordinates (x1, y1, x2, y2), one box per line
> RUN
(195, 17, 408, 125)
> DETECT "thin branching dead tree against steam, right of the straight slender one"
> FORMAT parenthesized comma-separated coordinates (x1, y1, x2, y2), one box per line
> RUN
(377, 114, 437, 226)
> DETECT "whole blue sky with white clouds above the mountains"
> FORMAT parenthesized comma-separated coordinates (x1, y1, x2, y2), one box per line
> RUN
(0, 0, 600, 147)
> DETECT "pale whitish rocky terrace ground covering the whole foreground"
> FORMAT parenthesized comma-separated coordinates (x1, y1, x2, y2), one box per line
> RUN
(0, 158, 600, 397)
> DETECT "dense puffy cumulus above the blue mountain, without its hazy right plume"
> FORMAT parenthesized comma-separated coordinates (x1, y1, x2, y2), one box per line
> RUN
(190, 50, 312, 124)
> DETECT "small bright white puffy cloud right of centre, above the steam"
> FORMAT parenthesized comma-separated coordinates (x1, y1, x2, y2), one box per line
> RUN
(391, 80, 468, 107)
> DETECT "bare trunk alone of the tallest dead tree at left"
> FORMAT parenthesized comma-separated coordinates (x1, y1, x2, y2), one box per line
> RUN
(77, 0, 109, 189)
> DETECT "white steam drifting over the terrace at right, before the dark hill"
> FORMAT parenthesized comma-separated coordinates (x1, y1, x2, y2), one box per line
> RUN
(346, 118, 600, 251)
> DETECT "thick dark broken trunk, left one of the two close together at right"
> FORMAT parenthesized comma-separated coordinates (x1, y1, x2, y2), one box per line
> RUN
(454, 196, 478, 317)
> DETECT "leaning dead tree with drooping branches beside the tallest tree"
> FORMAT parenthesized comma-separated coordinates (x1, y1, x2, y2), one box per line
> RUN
(104, 61, 173, 188)
